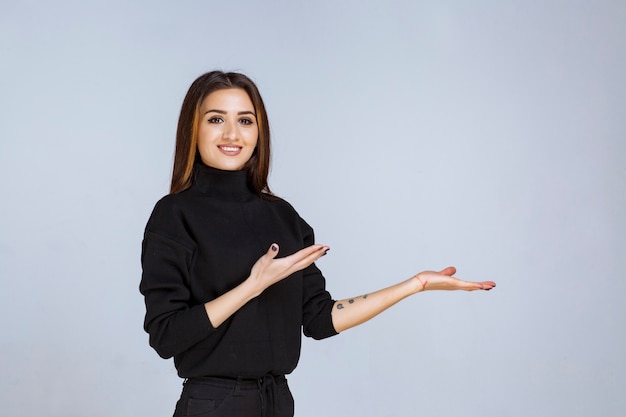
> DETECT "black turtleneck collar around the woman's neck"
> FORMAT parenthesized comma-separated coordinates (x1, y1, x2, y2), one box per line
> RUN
(193, 164, 256, 200)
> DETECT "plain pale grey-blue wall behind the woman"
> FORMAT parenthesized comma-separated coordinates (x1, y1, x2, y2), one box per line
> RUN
(0, 0, 626, 417)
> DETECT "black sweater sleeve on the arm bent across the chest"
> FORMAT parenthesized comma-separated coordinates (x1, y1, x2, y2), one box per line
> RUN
(139, 198, 214, 358)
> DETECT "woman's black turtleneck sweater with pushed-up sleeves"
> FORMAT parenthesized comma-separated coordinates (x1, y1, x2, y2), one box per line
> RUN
(140, 165, 337, 378)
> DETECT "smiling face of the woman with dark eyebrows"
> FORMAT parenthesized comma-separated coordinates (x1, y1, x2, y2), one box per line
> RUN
(198, 88, 259, 171)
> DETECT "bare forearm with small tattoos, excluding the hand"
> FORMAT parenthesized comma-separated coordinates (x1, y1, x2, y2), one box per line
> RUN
(332, 277, 423, 333)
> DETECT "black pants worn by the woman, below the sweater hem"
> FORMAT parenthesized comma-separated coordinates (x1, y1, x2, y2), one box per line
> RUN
(174, 375, 294, 417)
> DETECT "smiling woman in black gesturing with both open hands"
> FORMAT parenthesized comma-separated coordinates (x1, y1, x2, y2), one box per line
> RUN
(140, 71, 495, 417)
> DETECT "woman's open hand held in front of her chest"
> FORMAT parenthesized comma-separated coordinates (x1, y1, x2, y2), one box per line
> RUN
(248, 243, 330, 296)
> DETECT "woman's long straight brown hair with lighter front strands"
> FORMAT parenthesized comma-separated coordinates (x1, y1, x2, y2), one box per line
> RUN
(170, 71, 272, 196)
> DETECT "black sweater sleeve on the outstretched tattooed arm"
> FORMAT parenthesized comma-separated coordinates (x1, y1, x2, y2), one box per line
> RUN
(300, 219, 337, 340)
